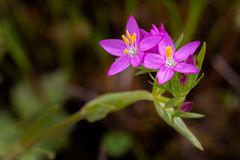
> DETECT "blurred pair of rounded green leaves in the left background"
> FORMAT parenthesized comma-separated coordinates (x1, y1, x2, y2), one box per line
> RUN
(11, 72, 67, 119)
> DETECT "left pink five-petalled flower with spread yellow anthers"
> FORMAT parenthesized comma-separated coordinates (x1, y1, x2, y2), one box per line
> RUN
(99, 16, 162, 76)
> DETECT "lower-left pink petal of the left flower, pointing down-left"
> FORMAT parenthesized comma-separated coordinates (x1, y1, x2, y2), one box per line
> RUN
(108, 55, 130, 76)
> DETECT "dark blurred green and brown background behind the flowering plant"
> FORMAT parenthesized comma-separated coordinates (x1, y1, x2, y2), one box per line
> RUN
(0, 0, 240, 160)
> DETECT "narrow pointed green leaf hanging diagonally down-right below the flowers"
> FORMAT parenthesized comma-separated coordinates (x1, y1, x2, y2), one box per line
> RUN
(154, 102, 203, 150)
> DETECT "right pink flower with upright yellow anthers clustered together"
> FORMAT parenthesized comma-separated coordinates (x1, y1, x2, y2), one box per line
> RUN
(143, 25, 200, 84)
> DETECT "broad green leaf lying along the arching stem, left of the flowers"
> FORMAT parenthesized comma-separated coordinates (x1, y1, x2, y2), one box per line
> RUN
(81, 90, 153, 122)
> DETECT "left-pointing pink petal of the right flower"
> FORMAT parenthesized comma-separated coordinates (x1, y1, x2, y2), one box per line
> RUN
(143, 53, 165, 69)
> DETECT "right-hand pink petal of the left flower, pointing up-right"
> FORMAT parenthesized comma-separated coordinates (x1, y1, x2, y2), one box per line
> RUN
(139, 36, 162, 51)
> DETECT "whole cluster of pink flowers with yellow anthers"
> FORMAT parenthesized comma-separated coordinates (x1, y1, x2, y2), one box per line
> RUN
(99, 16, 200, 84)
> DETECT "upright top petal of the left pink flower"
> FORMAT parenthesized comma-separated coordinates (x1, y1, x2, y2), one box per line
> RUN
(126, 16, 140, 42)
